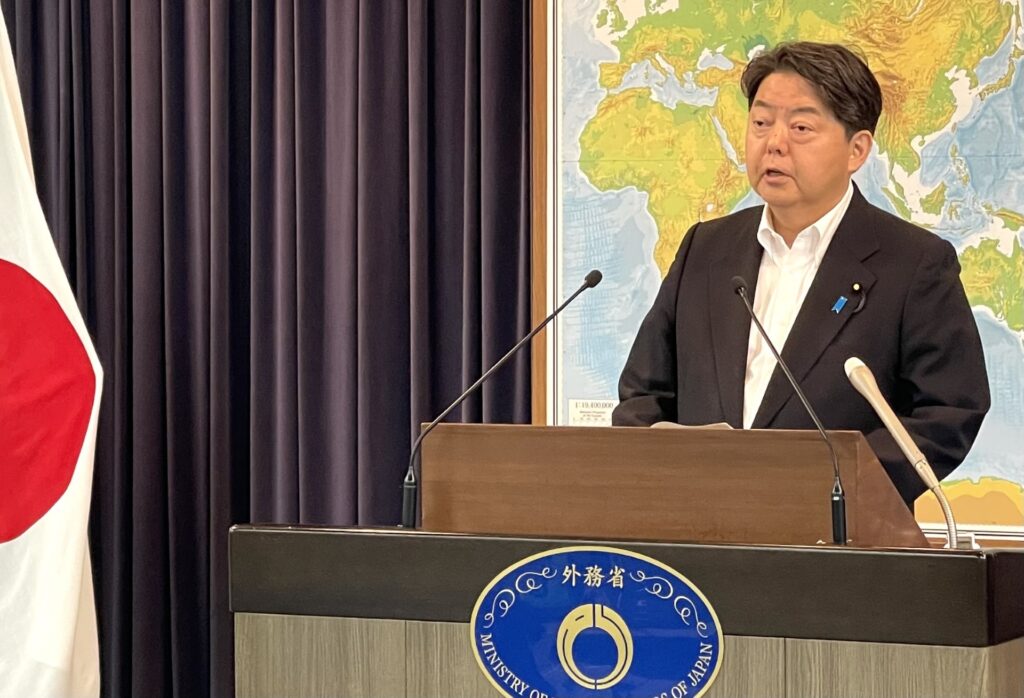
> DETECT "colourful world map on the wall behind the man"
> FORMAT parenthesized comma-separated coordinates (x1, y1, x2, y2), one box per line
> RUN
(553, 0, 1024, 535)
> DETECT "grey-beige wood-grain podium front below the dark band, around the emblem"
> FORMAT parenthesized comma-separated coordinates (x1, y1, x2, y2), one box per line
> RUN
(236, 613, 1024, 698)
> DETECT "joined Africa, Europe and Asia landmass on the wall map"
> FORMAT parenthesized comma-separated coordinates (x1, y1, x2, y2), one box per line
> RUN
(580, 0, 1016, 274)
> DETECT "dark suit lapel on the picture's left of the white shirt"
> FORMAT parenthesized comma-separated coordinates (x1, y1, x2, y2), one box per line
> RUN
(708, 214, 762, 429)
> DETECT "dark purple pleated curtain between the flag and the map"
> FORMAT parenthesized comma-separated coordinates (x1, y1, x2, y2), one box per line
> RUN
(0, 0, 529, 697)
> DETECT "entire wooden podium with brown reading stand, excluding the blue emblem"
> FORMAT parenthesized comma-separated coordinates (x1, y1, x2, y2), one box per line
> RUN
(229, 425, 1024, 698)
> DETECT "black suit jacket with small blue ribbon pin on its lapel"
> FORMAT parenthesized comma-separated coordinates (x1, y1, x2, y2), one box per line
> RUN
(612, 190, 989, 504)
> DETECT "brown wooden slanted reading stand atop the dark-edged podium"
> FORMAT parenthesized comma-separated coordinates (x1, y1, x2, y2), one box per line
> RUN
(421, 424, 928, 548)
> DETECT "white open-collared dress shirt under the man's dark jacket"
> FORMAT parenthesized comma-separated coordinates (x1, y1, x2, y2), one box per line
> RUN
(743, 183, 853, 429)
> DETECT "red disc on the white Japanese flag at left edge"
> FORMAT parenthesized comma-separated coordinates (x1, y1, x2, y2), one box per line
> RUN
(0, 260, 96, 543)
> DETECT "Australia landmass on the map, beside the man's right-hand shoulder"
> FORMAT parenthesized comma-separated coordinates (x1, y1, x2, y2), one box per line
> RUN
(959, 235, 1024, 332)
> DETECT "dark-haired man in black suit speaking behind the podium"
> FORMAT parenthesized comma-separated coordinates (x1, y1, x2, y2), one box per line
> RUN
(612, 42, 989, 505)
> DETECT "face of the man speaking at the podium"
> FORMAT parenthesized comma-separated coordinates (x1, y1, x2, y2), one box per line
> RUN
(746, 73, 871, 235)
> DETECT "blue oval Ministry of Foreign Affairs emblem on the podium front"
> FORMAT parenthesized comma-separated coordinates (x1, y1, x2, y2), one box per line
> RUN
(470, 547, 722, 698)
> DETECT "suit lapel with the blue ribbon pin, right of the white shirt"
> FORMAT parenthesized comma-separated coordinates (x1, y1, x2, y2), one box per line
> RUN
(752, 189, 879, 429)
